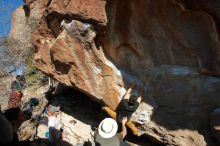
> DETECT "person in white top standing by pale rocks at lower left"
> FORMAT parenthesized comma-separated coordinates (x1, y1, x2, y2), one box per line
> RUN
(48, 106, 62, 146)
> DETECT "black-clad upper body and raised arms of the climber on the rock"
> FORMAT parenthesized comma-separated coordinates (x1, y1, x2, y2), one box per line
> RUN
(116, 84, 143, 131)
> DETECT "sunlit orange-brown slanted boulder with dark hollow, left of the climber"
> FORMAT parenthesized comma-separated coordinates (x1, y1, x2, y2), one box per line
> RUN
(34, 21, 123, 109)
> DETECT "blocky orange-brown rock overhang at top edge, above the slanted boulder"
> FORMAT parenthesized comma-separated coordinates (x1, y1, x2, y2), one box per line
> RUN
(49, 0, 107, 24)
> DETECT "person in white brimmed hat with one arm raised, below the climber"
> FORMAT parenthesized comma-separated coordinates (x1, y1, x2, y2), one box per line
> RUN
(95, 117, 129, 146)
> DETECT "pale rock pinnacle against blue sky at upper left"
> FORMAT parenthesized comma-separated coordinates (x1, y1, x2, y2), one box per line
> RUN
(9, 0, 48, 48)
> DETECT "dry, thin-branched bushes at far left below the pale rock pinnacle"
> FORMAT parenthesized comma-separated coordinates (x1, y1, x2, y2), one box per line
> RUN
(0, 12, 46, 85)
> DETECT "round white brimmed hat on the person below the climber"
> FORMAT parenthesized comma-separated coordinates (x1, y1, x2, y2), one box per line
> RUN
(98, 118, 118, 138)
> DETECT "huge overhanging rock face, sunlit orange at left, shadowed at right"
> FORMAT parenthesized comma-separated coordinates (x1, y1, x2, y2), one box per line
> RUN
(12, 0, 220, 146)
